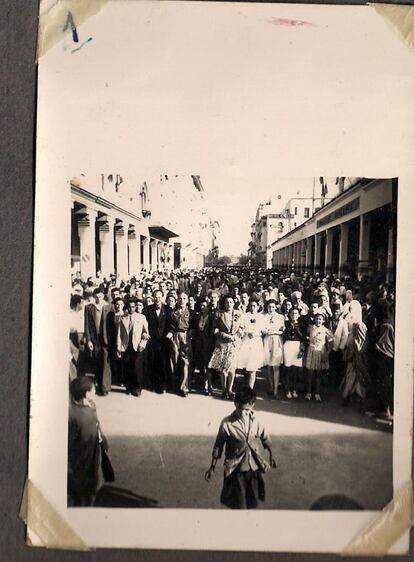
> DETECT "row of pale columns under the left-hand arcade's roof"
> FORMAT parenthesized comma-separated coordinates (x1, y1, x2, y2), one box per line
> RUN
(77, 203, 173, 280)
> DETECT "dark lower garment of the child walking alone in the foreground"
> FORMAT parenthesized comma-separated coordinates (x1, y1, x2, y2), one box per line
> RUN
(220, 470, 265, 509)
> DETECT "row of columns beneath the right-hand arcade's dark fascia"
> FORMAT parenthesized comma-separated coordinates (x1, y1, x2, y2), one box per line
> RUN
(273, 213, 394, 281)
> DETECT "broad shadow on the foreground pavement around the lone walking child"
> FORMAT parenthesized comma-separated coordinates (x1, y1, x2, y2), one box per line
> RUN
(101, 428, 393, 510)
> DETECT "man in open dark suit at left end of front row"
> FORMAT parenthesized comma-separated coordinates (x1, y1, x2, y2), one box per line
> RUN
(85, 287, 113, 396)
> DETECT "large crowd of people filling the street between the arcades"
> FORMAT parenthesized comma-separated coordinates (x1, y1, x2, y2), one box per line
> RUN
(70, 267, 394, 420)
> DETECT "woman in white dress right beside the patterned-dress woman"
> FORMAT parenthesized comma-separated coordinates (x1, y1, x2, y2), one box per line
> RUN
(238, 299, 264, 388)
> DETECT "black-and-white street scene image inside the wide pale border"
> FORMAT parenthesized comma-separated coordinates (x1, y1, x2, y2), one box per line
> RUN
(68, 174, 398, 510)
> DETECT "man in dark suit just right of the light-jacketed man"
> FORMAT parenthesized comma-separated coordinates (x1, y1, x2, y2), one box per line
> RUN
(146, 290, 171, 394)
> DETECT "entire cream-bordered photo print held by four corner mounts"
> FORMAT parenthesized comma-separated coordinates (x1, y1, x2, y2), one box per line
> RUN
(25, 0, 414, 555)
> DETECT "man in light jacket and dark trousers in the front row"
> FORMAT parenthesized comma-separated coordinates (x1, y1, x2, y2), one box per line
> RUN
(117, 297, 149, 397)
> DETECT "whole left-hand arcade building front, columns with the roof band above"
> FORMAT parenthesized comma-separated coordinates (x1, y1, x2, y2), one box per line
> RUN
(71, 186, 176, 280)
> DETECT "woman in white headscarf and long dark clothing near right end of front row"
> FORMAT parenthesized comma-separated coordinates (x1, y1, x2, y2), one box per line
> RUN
(342, 300, 370, 404)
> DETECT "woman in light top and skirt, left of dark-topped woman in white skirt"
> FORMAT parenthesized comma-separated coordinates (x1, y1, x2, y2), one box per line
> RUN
(263, 299, 285, 398)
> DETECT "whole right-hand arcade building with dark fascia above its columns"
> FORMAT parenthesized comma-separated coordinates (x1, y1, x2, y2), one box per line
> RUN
(272, 179, 397, 283)
